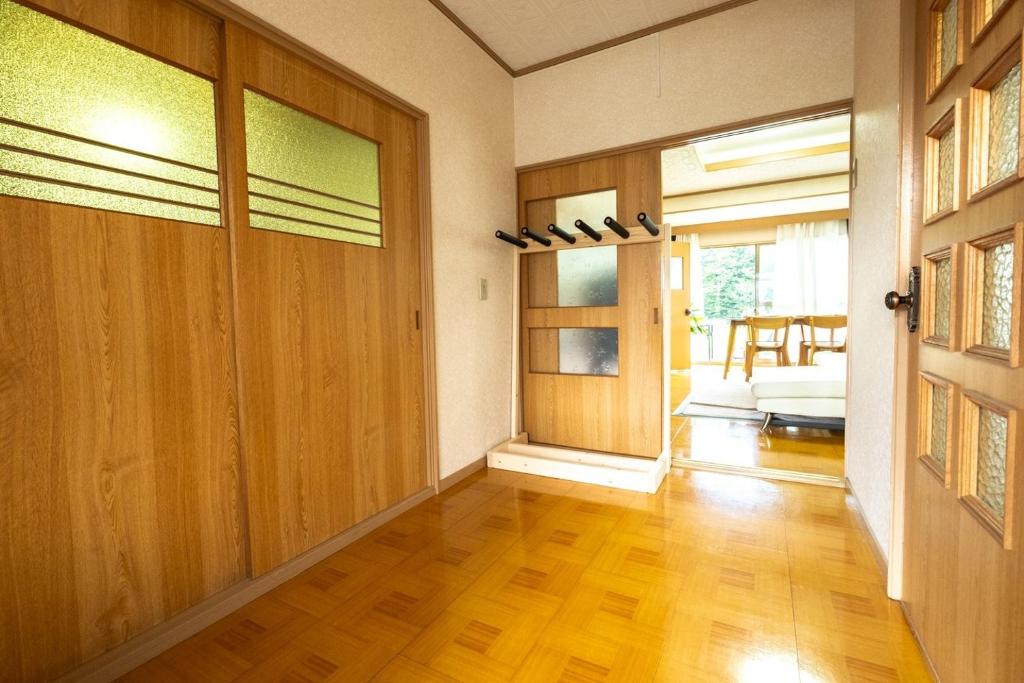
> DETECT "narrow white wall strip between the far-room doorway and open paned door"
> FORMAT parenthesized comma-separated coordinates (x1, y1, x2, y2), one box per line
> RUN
(846, 0, 905, 556)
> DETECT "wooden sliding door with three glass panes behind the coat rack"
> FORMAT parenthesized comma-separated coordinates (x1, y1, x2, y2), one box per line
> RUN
(519, 151, 669, 458)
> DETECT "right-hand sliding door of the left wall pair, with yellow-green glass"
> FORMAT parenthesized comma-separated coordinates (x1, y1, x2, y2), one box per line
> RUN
(225, 25, 429, 574)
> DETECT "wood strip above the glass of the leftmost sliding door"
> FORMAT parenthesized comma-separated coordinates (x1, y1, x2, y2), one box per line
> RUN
(18, 0, 221, 79)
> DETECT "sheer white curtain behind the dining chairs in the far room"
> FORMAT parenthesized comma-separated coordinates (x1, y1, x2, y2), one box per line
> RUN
(772, 220, 850, 315)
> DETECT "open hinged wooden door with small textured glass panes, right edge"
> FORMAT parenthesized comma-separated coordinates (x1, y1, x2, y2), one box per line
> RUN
(904, 0, 1024, 681)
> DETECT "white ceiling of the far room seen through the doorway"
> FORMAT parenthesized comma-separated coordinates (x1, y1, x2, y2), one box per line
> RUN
(662, 115, 850, 197)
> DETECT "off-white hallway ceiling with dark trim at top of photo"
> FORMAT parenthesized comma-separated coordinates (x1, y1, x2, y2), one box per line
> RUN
(442, 0, 741, 70)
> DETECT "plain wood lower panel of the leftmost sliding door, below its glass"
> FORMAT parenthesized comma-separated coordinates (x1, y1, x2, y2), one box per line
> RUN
(0, 198, 244, 679)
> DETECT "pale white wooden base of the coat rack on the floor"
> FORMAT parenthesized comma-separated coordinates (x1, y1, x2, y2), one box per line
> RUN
(487, 432, 672, 494)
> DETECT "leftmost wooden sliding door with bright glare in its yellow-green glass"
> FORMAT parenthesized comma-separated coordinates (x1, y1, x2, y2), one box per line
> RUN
(0, 0, 245, 680)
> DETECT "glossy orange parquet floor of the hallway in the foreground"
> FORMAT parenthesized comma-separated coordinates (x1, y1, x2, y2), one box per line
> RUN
(125, 470, 930, 683)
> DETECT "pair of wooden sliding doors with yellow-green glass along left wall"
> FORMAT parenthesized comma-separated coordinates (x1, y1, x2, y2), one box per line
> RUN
(0, 0, 434, 681)
